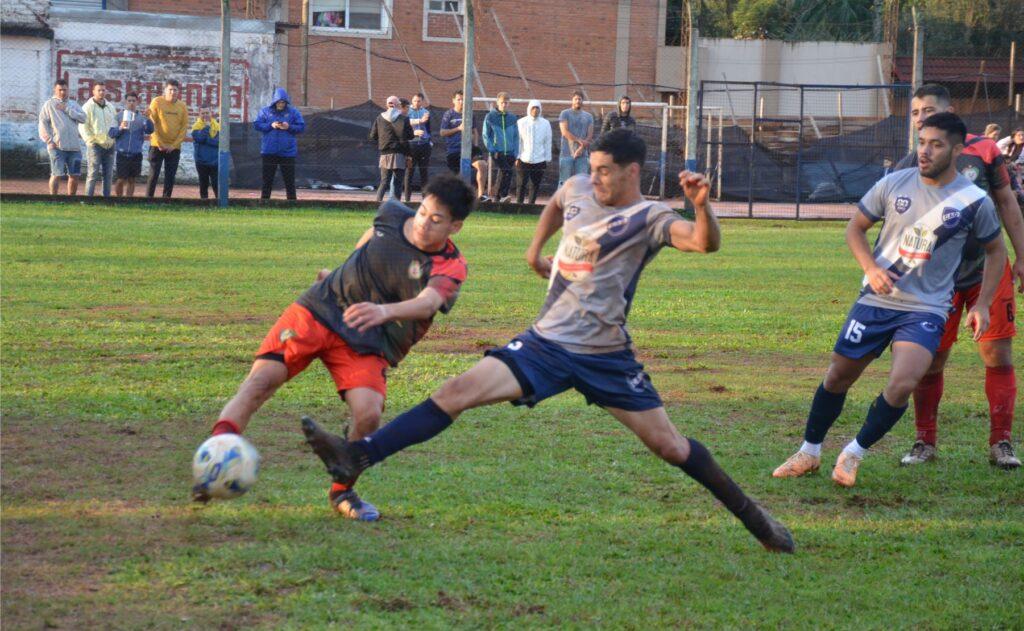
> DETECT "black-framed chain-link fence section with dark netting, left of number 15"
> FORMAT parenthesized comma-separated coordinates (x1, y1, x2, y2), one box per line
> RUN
(697, 81, 910, 218)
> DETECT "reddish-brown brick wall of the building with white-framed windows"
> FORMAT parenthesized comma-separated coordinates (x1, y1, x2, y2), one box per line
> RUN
(128, 0, 658, 108)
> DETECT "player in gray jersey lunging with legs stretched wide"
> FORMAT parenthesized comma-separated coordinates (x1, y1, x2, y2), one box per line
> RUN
(303, 129, 795, 552)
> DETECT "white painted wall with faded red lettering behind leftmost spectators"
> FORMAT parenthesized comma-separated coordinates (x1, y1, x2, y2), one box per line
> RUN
(0, 6, 280, 180)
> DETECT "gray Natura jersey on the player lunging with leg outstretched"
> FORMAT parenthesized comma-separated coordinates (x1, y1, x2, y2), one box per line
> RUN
(534, 175, 682, 353)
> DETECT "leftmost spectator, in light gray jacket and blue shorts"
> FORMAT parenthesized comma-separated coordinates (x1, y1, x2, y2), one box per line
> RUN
(39, 79, 85, 195)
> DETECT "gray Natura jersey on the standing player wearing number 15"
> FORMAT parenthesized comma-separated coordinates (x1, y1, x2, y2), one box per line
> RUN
(857, 169, 999, 317)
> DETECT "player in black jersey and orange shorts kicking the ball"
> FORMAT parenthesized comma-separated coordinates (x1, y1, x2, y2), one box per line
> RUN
(194, 174, 475, 521)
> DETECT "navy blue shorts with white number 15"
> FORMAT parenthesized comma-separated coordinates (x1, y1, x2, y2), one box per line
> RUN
(833, 304, 946, 360)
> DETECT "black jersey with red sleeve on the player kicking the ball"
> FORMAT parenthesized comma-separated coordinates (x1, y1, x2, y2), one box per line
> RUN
(298, 200, 467, 366)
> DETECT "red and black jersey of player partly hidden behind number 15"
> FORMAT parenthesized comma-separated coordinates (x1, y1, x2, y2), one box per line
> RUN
(893, 133, 1010, 291)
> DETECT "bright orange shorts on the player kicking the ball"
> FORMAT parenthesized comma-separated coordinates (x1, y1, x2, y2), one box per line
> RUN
(256, 303, 388, 396)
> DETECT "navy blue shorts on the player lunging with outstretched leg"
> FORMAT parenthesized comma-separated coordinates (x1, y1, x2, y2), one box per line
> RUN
(484, 330, 664, 412)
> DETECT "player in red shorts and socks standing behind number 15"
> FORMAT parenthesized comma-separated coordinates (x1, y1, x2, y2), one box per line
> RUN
(896, 84, 1024, 468)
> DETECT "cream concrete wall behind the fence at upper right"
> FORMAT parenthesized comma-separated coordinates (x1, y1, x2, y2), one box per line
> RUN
(657, 38, 892, 118)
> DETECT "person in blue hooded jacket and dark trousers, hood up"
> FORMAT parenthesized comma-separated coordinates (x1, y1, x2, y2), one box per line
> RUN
(253, 88, 306, 200)
